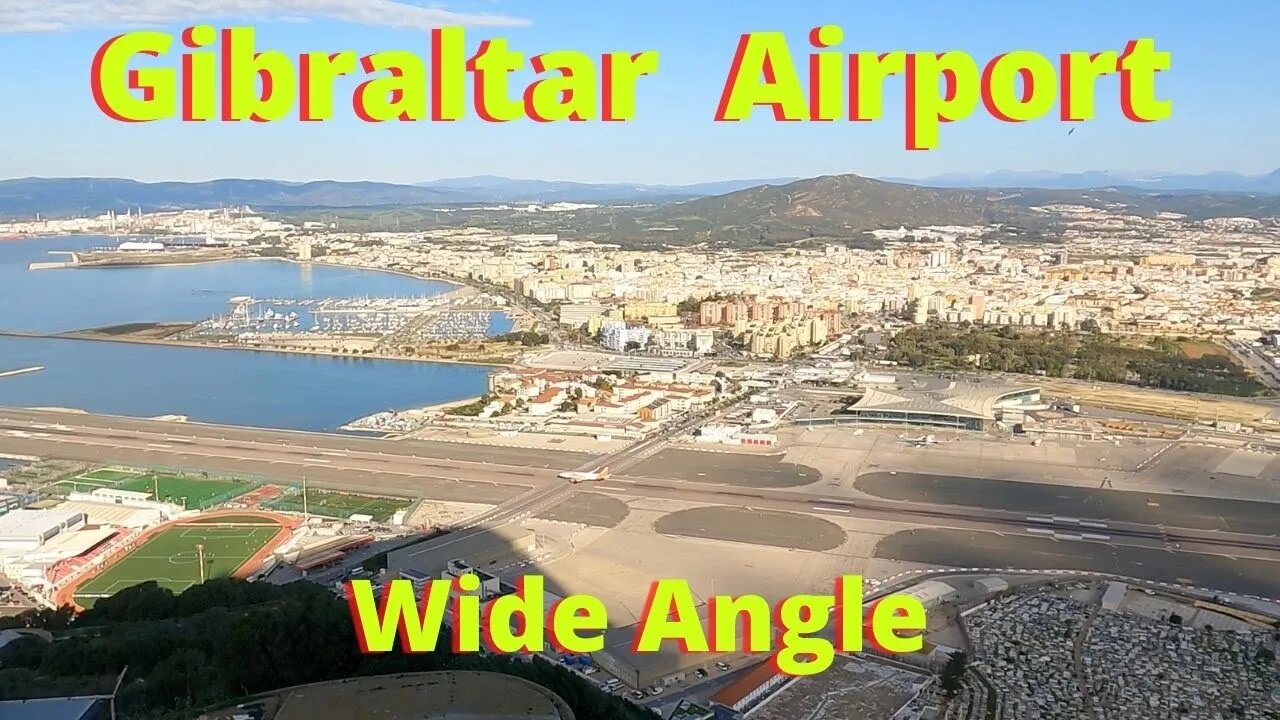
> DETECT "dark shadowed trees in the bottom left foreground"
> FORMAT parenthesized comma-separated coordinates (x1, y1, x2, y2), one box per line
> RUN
(0, 580, 652, 720)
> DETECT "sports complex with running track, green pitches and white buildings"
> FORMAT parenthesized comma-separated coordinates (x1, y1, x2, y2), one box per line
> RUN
(0, 466, 416, 609)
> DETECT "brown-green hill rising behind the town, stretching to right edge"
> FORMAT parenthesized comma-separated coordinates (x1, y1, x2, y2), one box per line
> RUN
(509, 174, 1280, 249)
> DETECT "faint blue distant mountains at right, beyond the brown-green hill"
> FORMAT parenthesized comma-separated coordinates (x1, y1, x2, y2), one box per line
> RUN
(886, 169, 1280, 195)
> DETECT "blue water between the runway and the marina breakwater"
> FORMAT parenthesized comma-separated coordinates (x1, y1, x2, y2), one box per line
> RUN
(0, 337, 489, 430)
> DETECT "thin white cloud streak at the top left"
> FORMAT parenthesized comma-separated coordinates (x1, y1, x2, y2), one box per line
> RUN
(0, 0, 530, 33)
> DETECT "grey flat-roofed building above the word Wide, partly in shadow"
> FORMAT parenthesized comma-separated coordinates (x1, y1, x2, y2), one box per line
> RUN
(387, 525, 538, 578)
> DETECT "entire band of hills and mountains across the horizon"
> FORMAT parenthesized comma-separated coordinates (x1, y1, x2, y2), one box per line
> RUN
(0, 174, 1280, 249)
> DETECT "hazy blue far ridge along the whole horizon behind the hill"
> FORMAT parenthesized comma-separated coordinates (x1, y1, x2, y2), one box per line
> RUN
(0, 170, 1280, 222)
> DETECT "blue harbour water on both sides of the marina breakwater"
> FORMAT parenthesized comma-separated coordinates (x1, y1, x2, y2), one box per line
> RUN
(0, 237, 494, 430)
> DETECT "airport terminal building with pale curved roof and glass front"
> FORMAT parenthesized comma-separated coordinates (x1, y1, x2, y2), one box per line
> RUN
(837, 383, 1041, 430)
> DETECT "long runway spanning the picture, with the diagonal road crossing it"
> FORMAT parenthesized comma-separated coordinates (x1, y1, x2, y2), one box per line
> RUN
(0, 409, 1280, 559)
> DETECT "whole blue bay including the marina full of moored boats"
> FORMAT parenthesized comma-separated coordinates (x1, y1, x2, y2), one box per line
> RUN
(0, 236, 512, 432)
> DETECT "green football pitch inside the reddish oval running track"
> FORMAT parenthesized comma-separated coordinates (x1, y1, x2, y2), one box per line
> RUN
(76, 518, 280, 607)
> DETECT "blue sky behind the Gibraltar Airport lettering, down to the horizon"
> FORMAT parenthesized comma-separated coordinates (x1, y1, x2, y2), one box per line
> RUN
(0, 0, 1280, 183)
